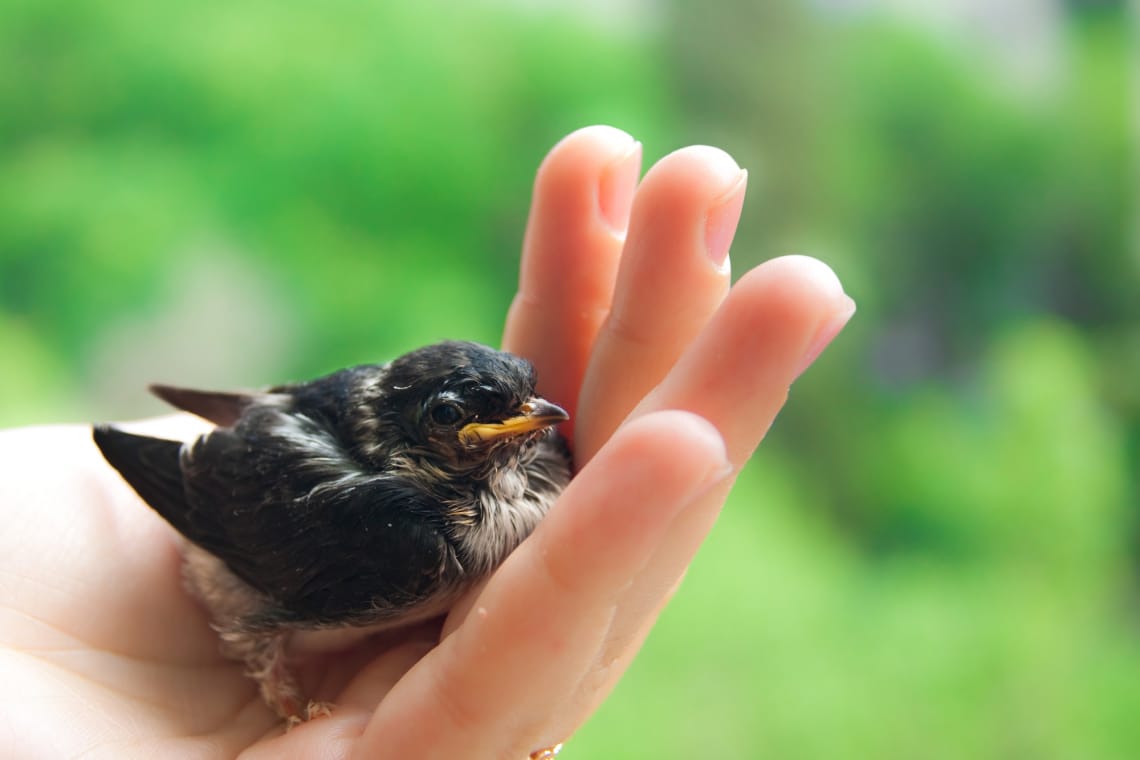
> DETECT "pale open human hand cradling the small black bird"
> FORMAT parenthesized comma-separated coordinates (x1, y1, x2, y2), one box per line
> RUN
(0, 126, 854, 760)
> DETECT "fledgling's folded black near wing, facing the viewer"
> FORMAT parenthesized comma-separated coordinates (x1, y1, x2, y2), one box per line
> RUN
(175, 426, 458, 627)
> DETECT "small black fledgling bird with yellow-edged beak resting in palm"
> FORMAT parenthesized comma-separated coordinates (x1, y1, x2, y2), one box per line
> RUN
(92, 341, 571, 726)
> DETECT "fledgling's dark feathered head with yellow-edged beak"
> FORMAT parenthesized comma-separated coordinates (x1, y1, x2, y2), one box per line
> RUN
(357, 342, 569, 484)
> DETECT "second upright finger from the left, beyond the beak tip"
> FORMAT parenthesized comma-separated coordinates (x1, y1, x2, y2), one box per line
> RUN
(575, 146, 747, 467)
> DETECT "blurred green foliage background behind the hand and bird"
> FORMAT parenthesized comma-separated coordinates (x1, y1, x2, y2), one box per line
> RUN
(0, 0, 1140, 760)
